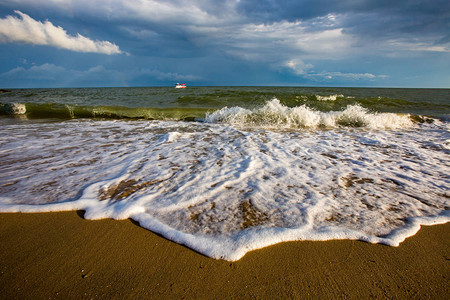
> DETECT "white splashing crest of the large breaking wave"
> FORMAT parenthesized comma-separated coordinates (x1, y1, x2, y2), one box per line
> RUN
(206, 99, 413, 129)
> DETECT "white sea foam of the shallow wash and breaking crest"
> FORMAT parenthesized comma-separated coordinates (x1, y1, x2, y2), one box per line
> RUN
(0, 117, 450, 260)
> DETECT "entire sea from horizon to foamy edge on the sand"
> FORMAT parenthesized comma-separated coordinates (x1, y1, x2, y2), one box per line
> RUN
(0, 87, 450, 261)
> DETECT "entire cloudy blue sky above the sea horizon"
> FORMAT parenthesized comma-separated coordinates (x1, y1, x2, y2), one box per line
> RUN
(0, 0, 450, 88)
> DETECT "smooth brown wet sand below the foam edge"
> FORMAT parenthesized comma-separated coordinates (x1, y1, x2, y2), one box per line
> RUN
(0, 212, 450, 299)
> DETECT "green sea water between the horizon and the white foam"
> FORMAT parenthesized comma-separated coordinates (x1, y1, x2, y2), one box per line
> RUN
(0, 87, 450, 120)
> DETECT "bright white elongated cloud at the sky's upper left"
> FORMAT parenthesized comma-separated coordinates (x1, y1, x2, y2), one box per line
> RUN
(0, 11, 123, 55)
